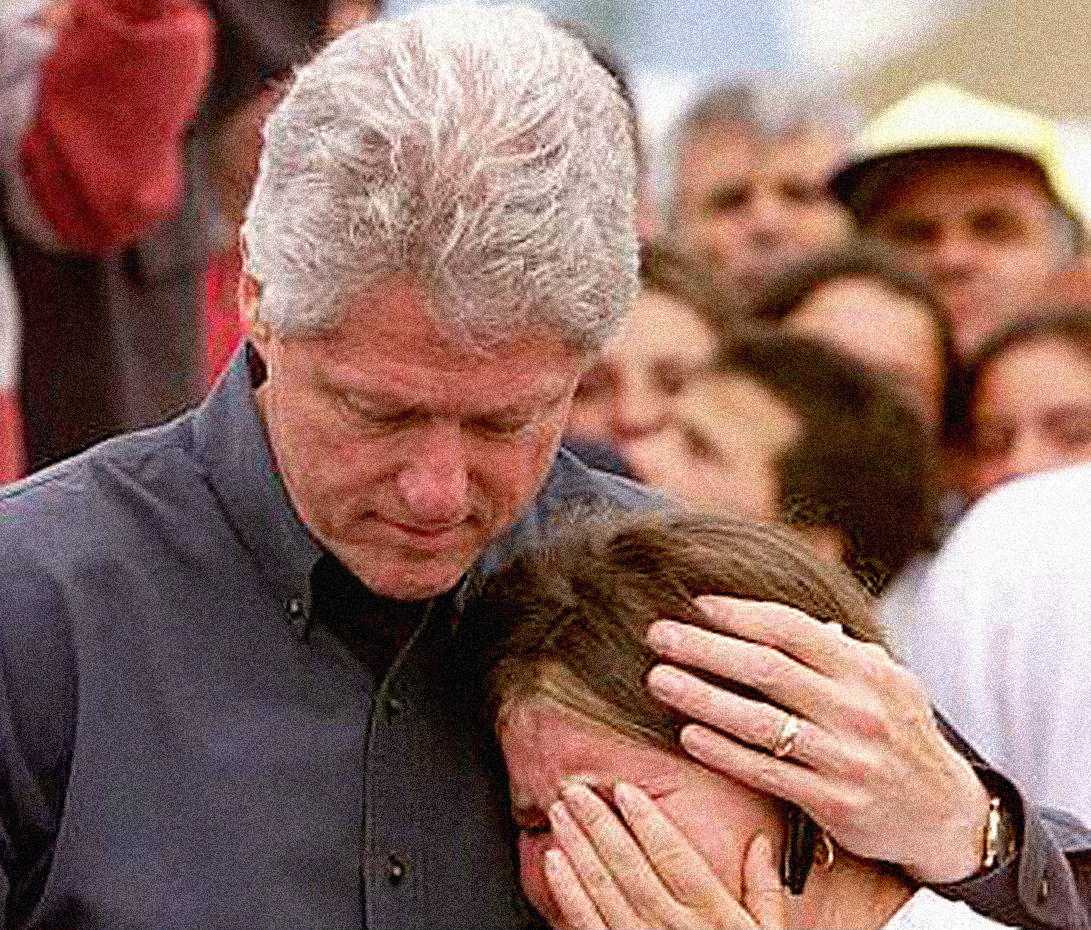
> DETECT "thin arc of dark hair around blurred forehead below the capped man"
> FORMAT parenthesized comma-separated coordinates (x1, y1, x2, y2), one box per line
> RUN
(754, 242, 962, 427)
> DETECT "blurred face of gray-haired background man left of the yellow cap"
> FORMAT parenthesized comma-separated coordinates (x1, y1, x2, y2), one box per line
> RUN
(671, 123, 850, 302)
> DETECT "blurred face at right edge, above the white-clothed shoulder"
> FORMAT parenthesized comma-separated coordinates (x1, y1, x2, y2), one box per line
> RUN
(969, 336, 1091, 498)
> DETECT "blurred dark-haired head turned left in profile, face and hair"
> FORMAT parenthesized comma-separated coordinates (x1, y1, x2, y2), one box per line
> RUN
(630, 336, 938, 592)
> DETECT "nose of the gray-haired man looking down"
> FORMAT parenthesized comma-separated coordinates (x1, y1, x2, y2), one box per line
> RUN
(397, 422, 469, 529)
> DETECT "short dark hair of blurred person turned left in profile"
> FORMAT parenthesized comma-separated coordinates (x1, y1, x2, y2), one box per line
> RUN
(718, 336, 938, 592)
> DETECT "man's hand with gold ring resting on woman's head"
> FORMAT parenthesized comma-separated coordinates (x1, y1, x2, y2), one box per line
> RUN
(648, 597, 990, 884)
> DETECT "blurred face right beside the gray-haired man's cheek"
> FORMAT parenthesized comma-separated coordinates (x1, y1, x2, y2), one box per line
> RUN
(566, 289, 716, 455)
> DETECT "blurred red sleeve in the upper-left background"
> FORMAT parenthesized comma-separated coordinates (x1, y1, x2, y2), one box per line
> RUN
(20, 0, 212, 254)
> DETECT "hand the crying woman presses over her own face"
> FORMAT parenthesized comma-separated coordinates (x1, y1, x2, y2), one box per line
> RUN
(546, 782, 788, 930)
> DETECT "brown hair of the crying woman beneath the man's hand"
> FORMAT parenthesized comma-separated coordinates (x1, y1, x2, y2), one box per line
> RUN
(473, 513, 880, 752)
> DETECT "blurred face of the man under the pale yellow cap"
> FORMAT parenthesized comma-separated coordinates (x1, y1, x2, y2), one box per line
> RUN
(867, 152, 1074, 354)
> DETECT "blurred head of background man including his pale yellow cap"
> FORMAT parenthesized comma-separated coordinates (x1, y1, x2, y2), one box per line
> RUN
(832, 83, 1083, 357)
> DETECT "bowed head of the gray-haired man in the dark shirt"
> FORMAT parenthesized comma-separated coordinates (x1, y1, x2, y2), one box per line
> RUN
(234, 5, 637, 600)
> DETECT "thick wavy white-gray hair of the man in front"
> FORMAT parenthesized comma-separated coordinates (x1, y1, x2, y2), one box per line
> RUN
(243, 4, 637, 351)
